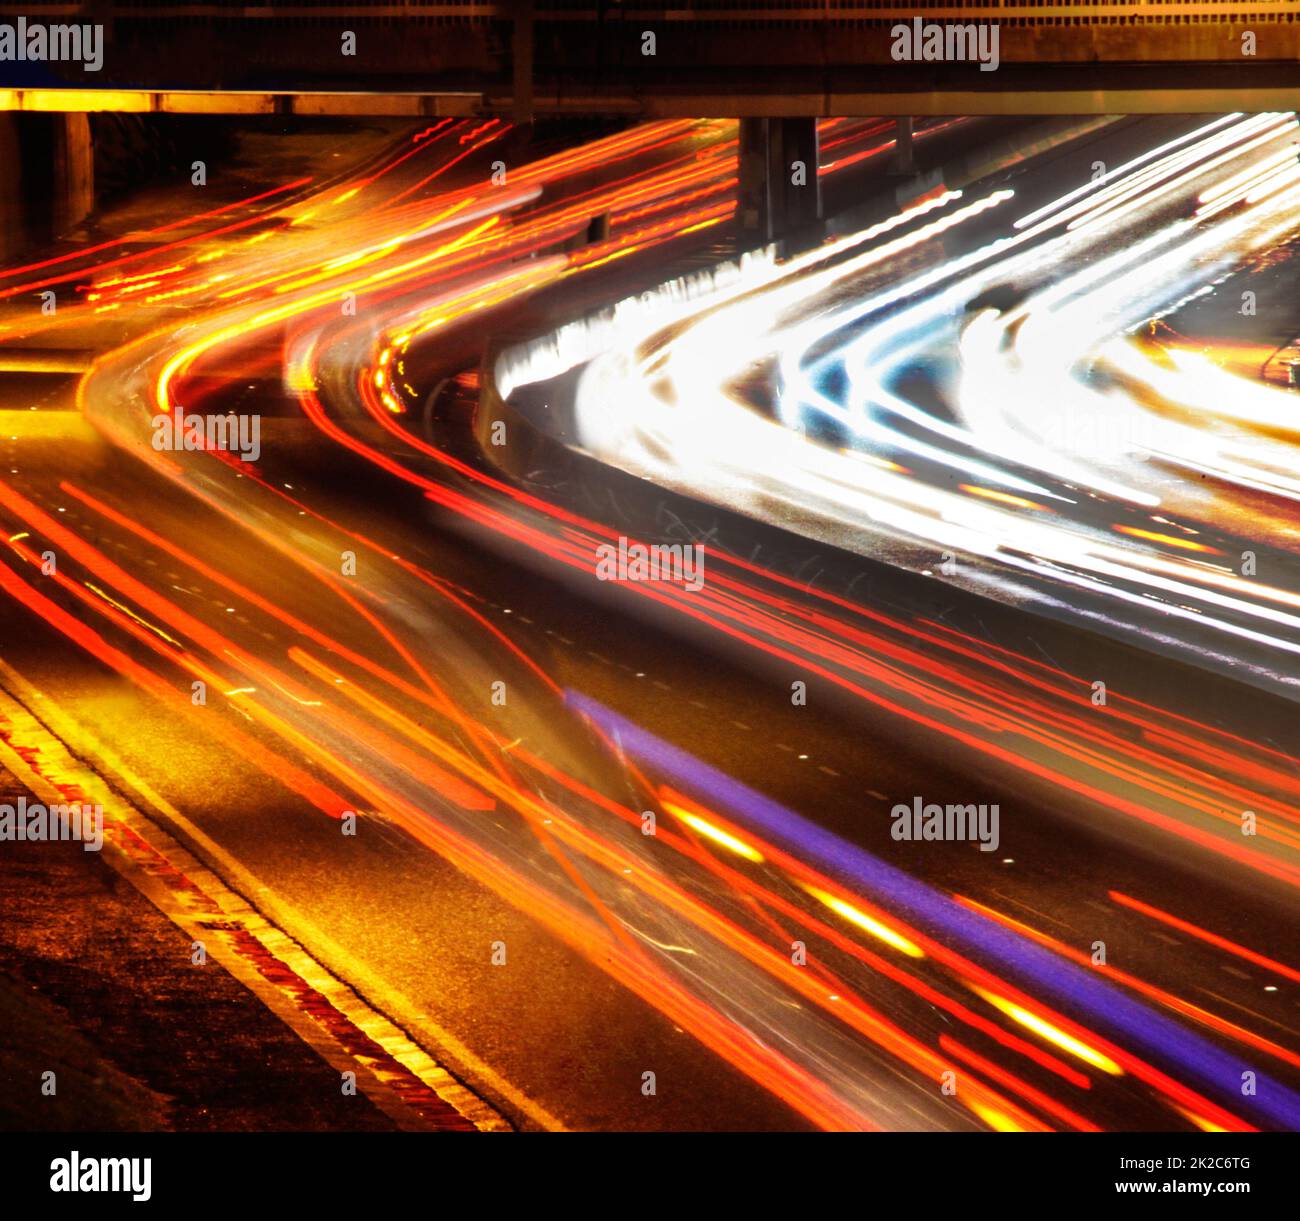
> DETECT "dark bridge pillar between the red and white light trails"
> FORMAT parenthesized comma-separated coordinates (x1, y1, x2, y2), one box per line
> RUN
(736, 118, 822, 250)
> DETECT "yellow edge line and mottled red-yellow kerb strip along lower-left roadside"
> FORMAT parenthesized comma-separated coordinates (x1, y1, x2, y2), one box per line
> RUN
(0, 661, 553, 1131)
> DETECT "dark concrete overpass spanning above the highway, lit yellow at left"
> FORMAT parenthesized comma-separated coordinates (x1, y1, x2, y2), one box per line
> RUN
(0, 7, 1300, 120)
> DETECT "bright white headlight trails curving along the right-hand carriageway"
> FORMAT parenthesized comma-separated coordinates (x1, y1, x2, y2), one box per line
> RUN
(502, 114, 1300, 688)
